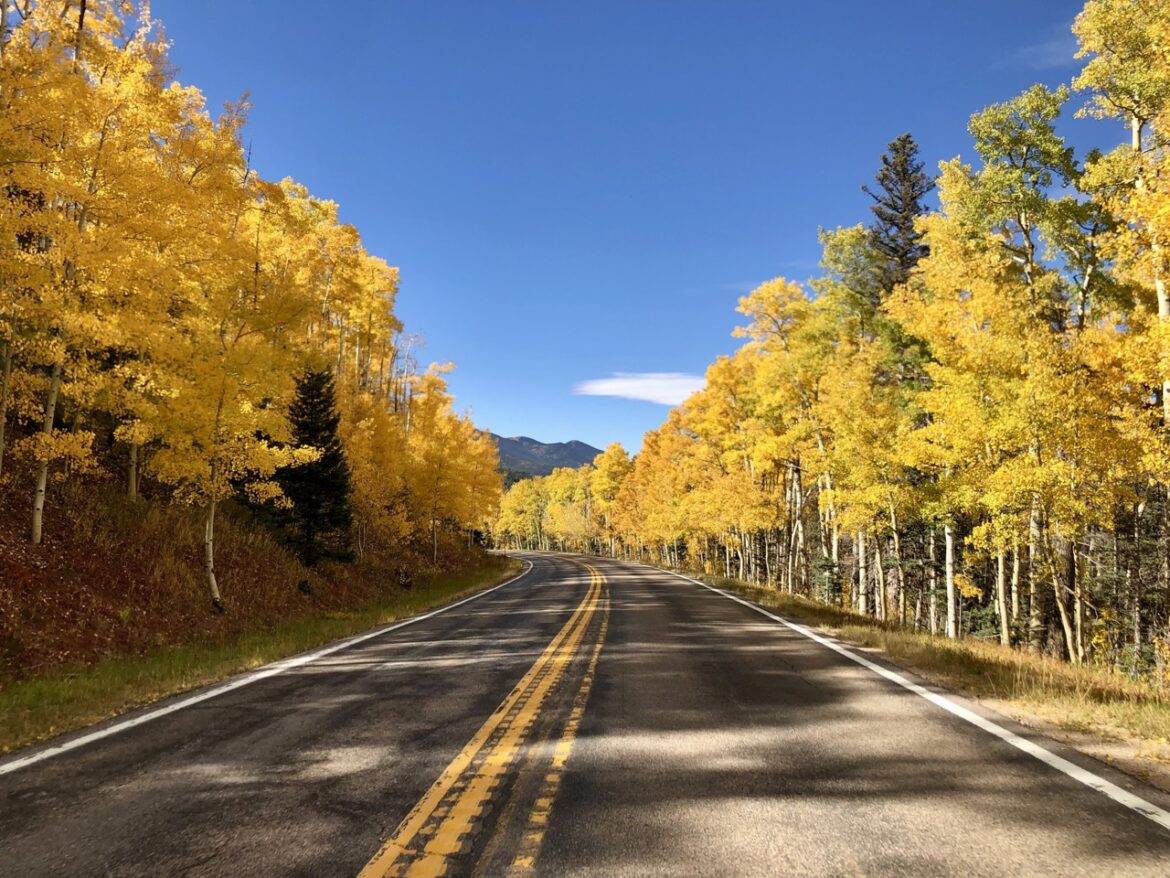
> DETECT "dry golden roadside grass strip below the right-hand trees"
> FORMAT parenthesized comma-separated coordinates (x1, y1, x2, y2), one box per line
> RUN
(700, 576, 1170, 762)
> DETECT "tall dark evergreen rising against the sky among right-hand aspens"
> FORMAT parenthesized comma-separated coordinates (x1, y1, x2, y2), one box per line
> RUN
(861, 133, 935, 293)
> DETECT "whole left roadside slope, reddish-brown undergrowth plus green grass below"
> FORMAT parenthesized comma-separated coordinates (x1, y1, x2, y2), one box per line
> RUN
(0, 473, 518, 749)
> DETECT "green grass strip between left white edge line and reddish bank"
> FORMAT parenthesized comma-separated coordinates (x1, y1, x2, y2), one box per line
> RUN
(0, 555, 522, 753)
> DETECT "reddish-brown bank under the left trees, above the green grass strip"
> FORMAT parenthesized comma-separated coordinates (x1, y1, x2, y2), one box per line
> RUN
(0, 472, 468, 686)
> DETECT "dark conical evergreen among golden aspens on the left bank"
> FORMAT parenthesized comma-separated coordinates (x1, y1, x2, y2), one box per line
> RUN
(277, 370, 353, 567)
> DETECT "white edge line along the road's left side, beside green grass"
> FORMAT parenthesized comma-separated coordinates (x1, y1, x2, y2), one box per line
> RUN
(0, 560, 532, 775)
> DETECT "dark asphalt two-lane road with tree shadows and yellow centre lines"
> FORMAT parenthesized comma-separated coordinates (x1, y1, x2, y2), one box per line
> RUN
(0, 555, 1170, 878)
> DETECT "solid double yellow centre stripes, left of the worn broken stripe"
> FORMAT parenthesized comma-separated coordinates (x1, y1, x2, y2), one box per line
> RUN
(358, 564, 605, 878)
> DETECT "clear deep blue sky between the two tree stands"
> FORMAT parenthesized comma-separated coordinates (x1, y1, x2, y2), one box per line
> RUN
(153, 0, 1104, 451)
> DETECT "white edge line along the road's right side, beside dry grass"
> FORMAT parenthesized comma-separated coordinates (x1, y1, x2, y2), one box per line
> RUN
(655, 568, 1170, 830)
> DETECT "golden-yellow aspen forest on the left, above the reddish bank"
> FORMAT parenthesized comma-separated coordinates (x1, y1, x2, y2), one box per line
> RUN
(0, 0, 502, 624)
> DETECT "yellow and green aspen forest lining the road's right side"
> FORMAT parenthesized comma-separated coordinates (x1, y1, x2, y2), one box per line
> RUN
(494, 0, 1170, 677)
